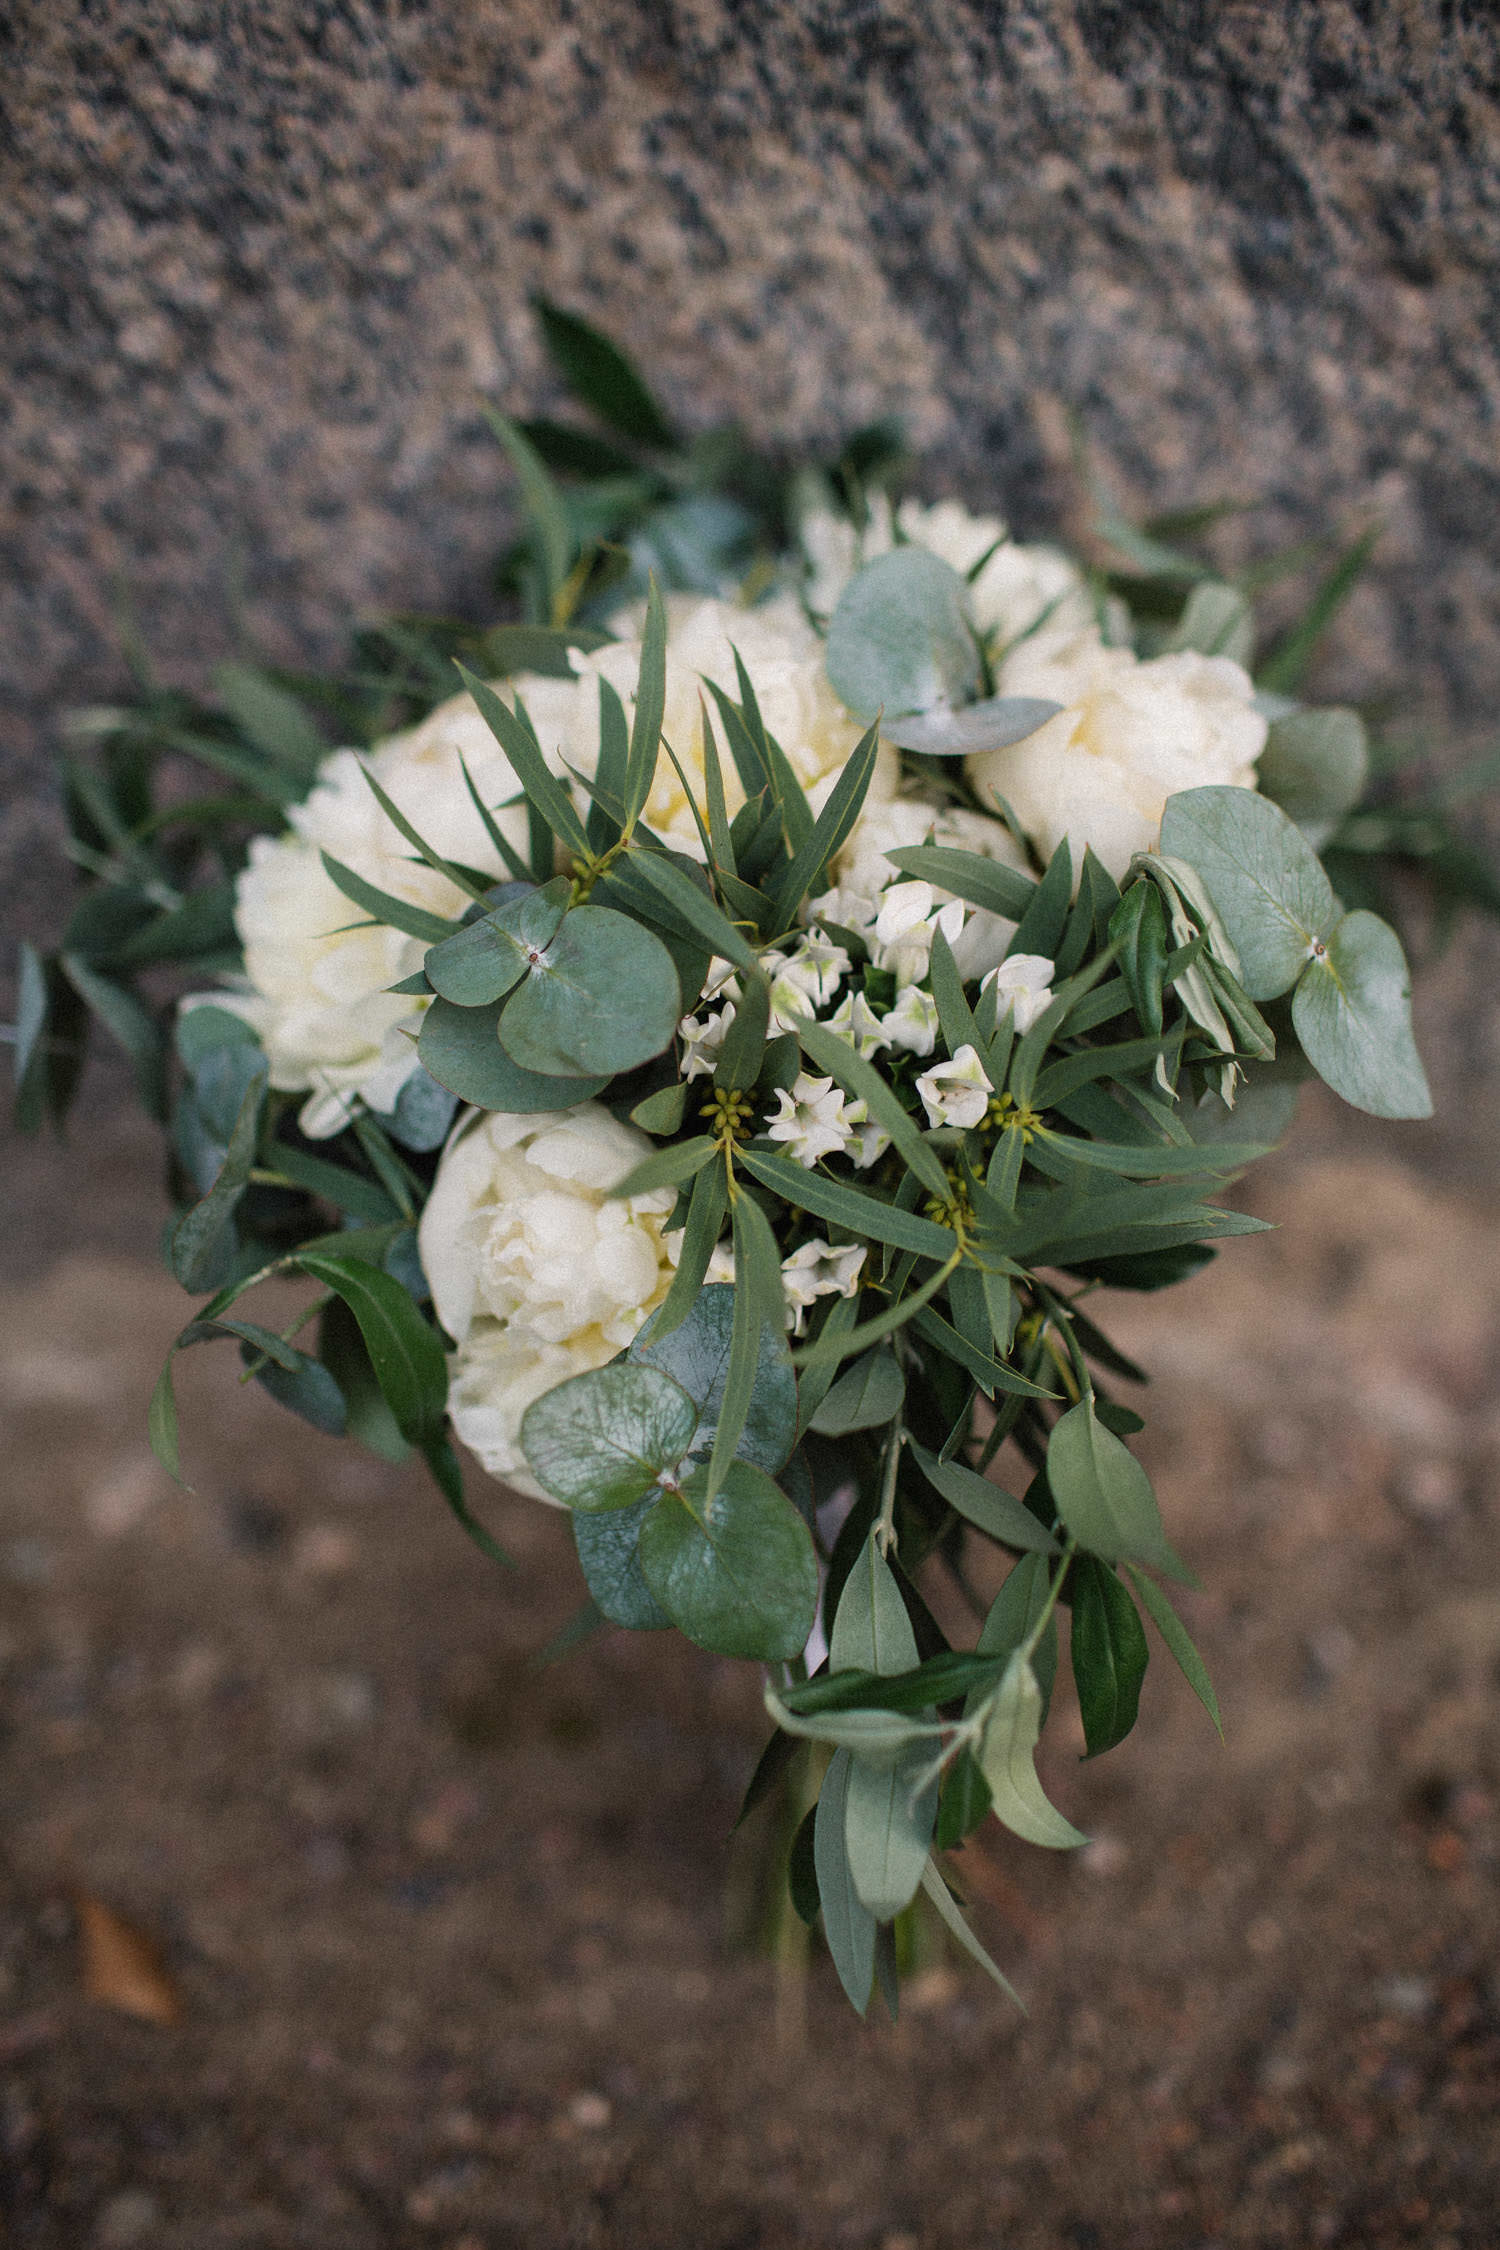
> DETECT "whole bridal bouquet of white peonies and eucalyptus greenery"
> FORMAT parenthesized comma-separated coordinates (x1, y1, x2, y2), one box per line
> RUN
(18, 308, 1484, 2012)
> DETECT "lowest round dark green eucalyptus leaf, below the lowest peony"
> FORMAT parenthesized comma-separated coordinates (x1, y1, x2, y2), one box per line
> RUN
(638, 1449, 819, 1663)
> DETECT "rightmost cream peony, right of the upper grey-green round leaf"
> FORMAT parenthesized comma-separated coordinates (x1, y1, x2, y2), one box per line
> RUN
(967, 632, 1266, 878)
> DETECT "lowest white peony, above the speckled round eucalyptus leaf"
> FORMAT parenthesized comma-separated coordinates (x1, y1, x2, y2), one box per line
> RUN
(418, 1103, 681, 1499)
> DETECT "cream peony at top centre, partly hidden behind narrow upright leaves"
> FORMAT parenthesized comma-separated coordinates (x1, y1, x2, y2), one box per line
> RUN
(515, 594, 881, 860)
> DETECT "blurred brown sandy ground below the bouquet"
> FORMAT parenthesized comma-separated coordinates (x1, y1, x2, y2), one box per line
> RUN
(0, 1111, 1500, 2250)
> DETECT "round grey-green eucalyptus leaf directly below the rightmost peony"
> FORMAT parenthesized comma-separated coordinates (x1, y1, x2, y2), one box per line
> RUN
(1160, 788, 1338, 999)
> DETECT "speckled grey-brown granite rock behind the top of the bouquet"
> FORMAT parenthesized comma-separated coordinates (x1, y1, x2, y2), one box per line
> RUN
(0, 0, 1500, 972)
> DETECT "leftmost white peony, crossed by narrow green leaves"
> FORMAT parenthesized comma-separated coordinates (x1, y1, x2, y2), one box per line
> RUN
(214, 695, 550, 1141)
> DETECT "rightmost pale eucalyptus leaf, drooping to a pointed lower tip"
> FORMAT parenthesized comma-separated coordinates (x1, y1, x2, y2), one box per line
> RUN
(1291, 907, 1433, 1118)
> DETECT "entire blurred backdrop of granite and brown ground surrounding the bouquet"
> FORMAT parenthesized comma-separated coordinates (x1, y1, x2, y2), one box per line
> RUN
(0, 0, 1500, 2250)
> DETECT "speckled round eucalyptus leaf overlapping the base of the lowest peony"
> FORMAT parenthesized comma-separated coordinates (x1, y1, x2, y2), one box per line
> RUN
(522, 1361, 697, 1508)
